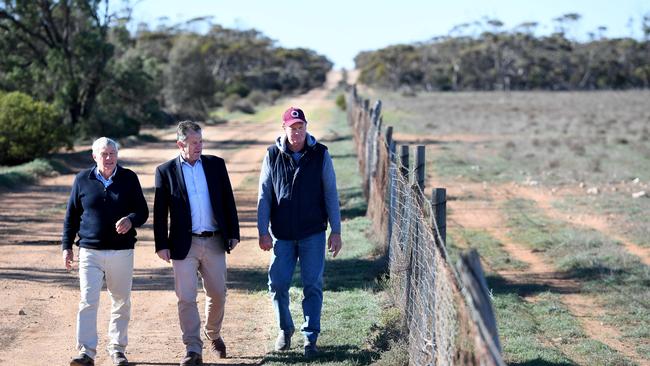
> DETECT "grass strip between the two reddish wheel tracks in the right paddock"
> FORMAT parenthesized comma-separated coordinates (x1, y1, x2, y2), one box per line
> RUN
(498, 199, 650, 359)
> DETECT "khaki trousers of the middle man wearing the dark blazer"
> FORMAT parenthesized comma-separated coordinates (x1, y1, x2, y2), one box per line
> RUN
(172, 235, 226, 354)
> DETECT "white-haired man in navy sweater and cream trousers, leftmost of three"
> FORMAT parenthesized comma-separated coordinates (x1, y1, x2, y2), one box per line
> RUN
(62, 137, 149, 366)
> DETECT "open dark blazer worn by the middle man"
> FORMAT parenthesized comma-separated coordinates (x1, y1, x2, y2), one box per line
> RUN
(153, 155, 239, 260)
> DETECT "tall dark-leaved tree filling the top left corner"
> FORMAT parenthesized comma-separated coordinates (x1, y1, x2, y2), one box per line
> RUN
(0, 0, 114, 126)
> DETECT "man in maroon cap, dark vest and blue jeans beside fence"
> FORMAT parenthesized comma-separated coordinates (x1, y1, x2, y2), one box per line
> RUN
(257, 107, 343, 358)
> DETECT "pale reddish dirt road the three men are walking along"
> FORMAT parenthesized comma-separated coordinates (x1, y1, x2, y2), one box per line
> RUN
(0, 73, 340, 365)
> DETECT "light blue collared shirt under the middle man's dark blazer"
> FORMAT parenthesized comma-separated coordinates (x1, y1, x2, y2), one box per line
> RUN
(179, 156, 219, 234)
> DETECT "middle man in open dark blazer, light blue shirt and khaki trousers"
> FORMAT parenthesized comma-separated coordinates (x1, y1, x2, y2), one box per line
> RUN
(153, 121, 239, 365)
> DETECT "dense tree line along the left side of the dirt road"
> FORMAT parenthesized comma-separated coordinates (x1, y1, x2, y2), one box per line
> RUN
(0, 0, 332, 164)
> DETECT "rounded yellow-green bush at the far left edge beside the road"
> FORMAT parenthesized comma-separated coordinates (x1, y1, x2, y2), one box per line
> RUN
(0, 92, 69, 165)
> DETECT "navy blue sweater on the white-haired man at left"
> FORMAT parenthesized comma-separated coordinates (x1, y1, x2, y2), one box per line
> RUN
(62, 165, 149, 250)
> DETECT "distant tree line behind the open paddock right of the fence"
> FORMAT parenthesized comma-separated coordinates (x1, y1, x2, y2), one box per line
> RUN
(355, 13, 650, 91)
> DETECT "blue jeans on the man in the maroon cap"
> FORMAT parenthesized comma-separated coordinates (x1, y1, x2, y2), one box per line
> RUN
(269, 231, 325, 344)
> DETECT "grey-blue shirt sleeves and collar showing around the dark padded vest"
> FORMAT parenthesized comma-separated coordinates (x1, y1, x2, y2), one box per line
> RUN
(257, 134, 341, 236)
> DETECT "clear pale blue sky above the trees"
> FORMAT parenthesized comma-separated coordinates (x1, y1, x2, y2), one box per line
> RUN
(117, 0, 650, 69)
